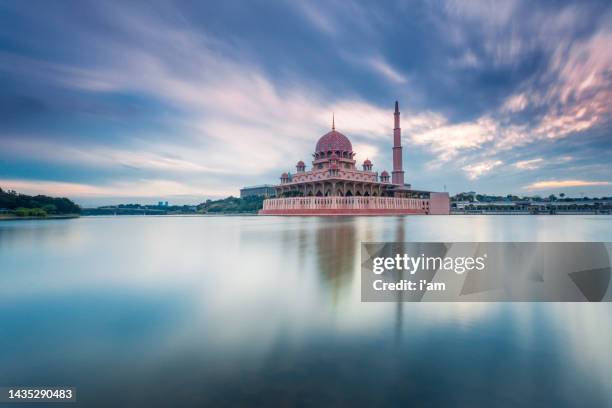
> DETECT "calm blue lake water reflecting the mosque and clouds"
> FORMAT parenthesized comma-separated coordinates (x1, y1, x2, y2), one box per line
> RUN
(0, 216, 612, 407)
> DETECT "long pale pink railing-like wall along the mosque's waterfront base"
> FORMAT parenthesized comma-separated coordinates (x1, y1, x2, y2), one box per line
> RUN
(263, 196, 429, 210)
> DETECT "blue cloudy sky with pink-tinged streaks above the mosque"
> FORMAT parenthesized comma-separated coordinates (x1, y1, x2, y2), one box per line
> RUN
(0, 0, 612, 206)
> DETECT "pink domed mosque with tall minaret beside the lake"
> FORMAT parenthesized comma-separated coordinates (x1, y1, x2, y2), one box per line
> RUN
(259, 101, 450, 215)
